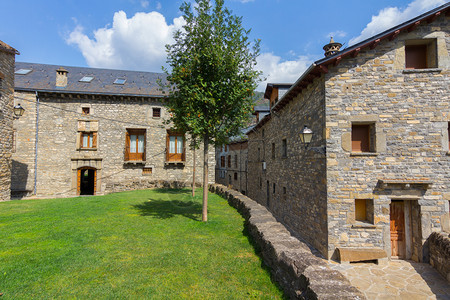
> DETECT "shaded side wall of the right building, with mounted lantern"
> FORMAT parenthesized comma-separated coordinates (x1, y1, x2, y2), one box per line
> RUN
(248, 78, 328, 256)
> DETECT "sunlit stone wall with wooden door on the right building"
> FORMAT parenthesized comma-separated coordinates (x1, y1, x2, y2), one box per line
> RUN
(324, 15, 450, 261)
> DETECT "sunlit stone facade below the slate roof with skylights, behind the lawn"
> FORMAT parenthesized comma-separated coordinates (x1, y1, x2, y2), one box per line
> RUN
(12, 66, 215, 197)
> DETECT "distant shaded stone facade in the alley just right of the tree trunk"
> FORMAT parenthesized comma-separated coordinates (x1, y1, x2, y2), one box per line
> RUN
(215, 141, 248, 195)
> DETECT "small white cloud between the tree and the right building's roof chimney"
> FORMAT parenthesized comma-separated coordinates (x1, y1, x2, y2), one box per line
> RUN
(256, 53, 313, 91)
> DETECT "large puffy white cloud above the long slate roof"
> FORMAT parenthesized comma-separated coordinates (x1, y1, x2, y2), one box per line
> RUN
(66, 11, 184, 72)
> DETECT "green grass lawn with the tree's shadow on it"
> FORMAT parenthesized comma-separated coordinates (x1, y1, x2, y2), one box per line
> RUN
(0, 189, 283, 299)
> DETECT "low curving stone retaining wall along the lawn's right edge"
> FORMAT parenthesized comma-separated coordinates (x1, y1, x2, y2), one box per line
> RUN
(210, 184, 365, 299)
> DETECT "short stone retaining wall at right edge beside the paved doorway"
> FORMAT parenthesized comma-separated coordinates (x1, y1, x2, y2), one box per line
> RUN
(429, 232, 450, 282)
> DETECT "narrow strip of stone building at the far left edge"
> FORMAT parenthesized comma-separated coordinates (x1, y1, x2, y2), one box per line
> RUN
(0, 41, 19, 201)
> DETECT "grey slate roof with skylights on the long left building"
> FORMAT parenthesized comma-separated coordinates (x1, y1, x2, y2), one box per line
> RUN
(15, 62, 166, 97)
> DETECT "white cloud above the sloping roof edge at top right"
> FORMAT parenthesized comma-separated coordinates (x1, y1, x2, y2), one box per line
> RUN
(349, 0, 446, 45)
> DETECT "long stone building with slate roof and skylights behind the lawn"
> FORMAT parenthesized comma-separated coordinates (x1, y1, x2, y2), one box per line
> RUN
(11, 63, 214, 197)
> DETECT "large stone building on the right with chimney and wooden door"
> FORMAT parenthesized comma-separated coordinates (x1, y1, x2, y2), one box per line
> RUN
(248, 3, 450, 262)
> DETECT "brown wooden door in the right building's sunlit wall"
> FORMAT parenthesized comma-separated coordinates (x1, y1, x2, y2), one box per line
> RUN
(390, 201, 406, 258)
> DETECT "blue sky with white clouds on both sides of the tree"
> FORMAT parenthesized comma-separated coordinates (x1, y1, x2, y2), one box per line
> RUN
(0, 0, 449, 89)
